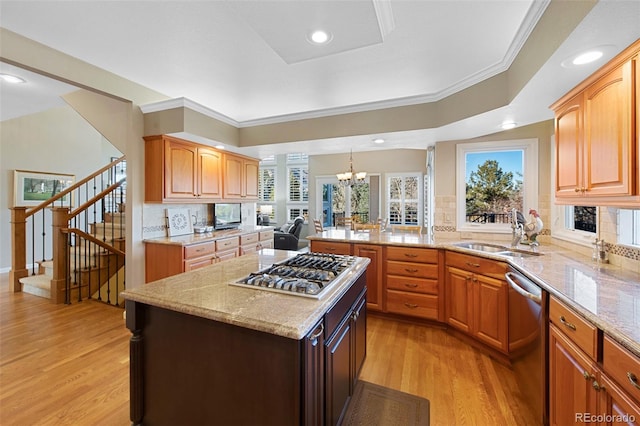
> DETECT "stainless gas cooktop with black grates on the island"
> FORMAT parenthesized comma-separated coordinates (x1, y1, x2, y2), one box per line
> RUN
(232, 253, 355, 299)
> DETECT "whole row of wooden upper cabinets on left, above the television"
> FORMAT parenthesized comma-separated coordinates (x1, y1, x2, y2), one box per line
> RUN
(144, 135, 258, 203)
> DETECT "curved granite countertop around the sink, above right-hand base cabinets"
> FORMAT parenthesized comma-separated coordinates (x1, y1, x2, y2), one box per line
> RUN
(307, 229, 640, 357)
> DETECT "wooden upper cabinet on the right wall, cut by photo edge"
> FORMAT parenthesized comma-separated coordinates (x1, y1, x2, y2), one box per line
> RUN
(551, 40, 640, 207)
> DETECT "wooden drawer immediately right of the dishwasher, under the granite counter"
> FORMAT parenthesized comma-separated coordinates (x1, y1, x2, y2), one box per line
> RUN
(549, 297, 598, 359)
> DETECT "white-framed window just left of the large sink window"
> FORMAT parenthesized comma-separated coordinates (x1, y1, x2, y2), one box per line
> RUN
(387, 173, 422, 225)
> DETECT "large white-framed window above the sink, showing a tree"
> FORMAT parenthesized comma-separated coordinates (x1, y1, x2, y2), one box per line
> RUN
(456, 139, 539, 233)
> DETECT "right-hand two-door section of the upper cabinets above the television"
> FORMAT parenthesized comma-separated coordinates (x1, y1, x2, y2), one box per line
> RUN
(224, 153, 260, 200)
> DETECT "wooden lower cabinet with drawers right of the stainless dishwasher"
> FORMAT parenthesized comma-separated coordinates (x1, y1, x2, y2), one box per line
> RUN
(549, 298, 640, 426)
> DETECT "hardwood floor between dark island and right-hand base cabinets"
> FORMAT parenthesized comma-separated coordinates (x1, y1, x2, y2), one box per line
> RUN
(360, 315, 539, 426)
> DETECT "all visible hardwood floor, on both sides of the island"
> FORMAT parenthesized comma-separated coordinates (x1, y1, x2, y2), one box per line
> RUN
(0, 274, 535, 426)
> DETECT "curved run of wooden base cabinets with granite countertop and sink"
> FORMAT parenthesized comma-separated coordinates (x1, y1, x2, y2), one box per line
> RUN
(307, 229, 640, 424)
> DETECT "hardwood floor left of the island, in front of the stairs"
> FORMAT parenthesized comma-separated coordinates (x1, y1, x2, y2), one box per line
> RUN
(0, 274, 130, 426)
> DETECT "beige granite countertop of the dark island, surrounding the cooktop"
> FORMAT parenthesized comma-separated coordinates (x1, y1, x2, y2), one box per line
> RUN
(122, 249, 369, 340)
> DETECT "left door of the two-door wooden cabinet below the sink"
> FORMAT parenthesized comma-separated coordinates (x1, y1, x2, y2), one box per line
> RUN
(446, 266, 473, 333)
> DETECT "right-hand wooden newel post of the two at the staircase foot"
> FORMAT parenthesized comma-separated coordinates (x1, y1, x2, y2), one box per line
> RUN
(51, 207, 71, 303)
